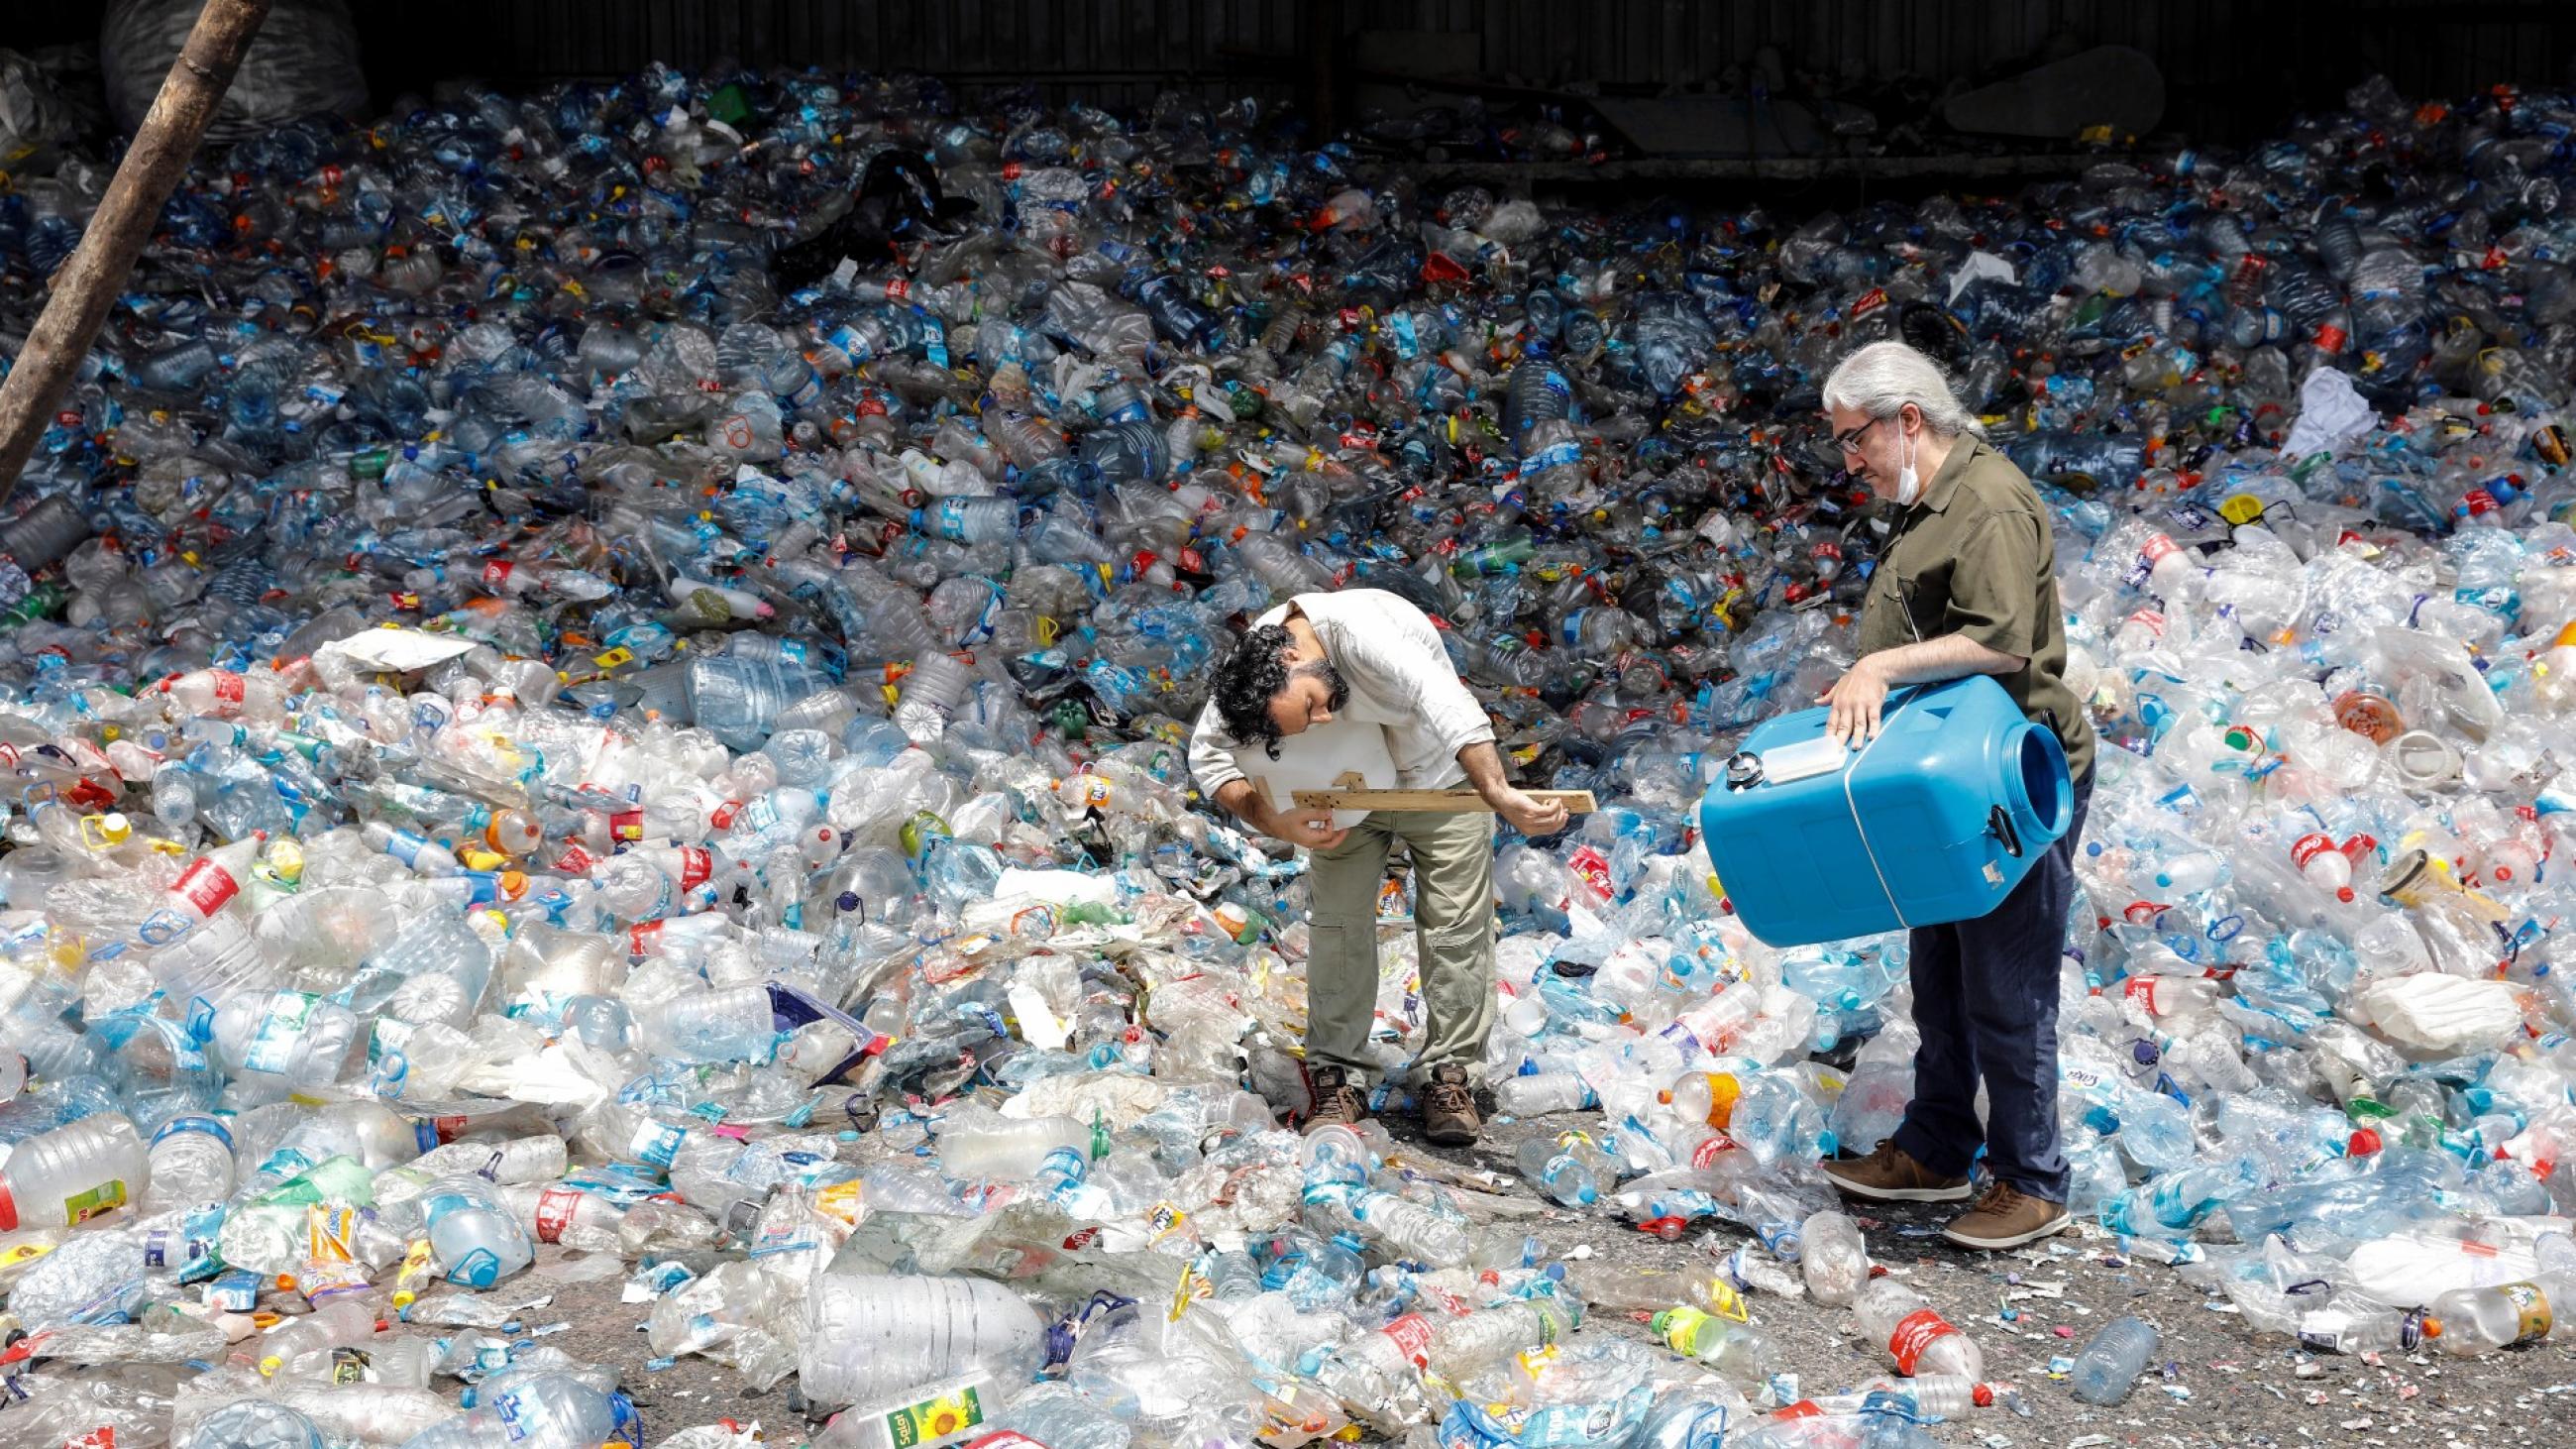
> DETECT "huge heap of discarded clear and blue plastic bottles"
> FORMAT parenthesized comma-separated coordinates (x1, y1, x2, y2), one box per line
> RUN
(0, 69, 2576, 1449)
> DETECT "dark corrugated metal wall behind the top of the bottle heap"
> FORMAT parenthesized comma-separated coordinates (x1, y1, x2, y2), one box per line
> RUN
(25, 0, 2576, 139)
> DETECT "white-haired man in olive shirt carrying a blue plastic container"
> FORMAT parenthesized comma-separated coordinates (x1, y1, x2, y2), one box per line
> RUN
(1824, 343, 2094, 1251)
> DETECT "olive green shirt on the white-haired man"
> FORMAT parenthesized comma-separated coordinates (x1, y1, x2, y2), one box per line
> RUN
(1860, 433, 2094, 784)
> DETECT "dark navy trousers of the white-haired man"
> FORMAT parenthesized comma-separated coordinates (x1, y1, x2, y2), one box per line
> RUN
(1896, 781, 2092, 1201)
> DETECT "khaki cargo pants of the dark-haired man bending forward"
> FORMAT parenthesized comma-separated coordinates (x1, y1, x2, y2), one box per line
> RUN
(1306, 810, 1494, 1085)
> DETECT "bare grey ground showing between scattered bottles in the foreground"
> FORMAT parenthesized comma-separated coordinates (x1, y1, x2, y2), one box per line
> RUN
(486, 1093, 2576, 1449)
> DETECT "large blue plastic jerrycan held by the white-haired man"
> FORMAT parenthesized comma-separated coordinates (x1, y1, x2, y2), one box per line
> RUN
(1700, 676, 2074, 947)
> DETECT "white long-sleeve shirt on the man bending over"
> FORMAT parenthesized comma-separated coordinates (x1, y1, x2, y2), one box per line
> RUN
(1190, 588, 1494, 799)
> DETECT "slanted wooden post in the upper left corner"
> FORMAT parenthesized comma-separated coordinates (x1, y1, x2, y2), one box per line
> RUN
(0, 0, 268, 502)
